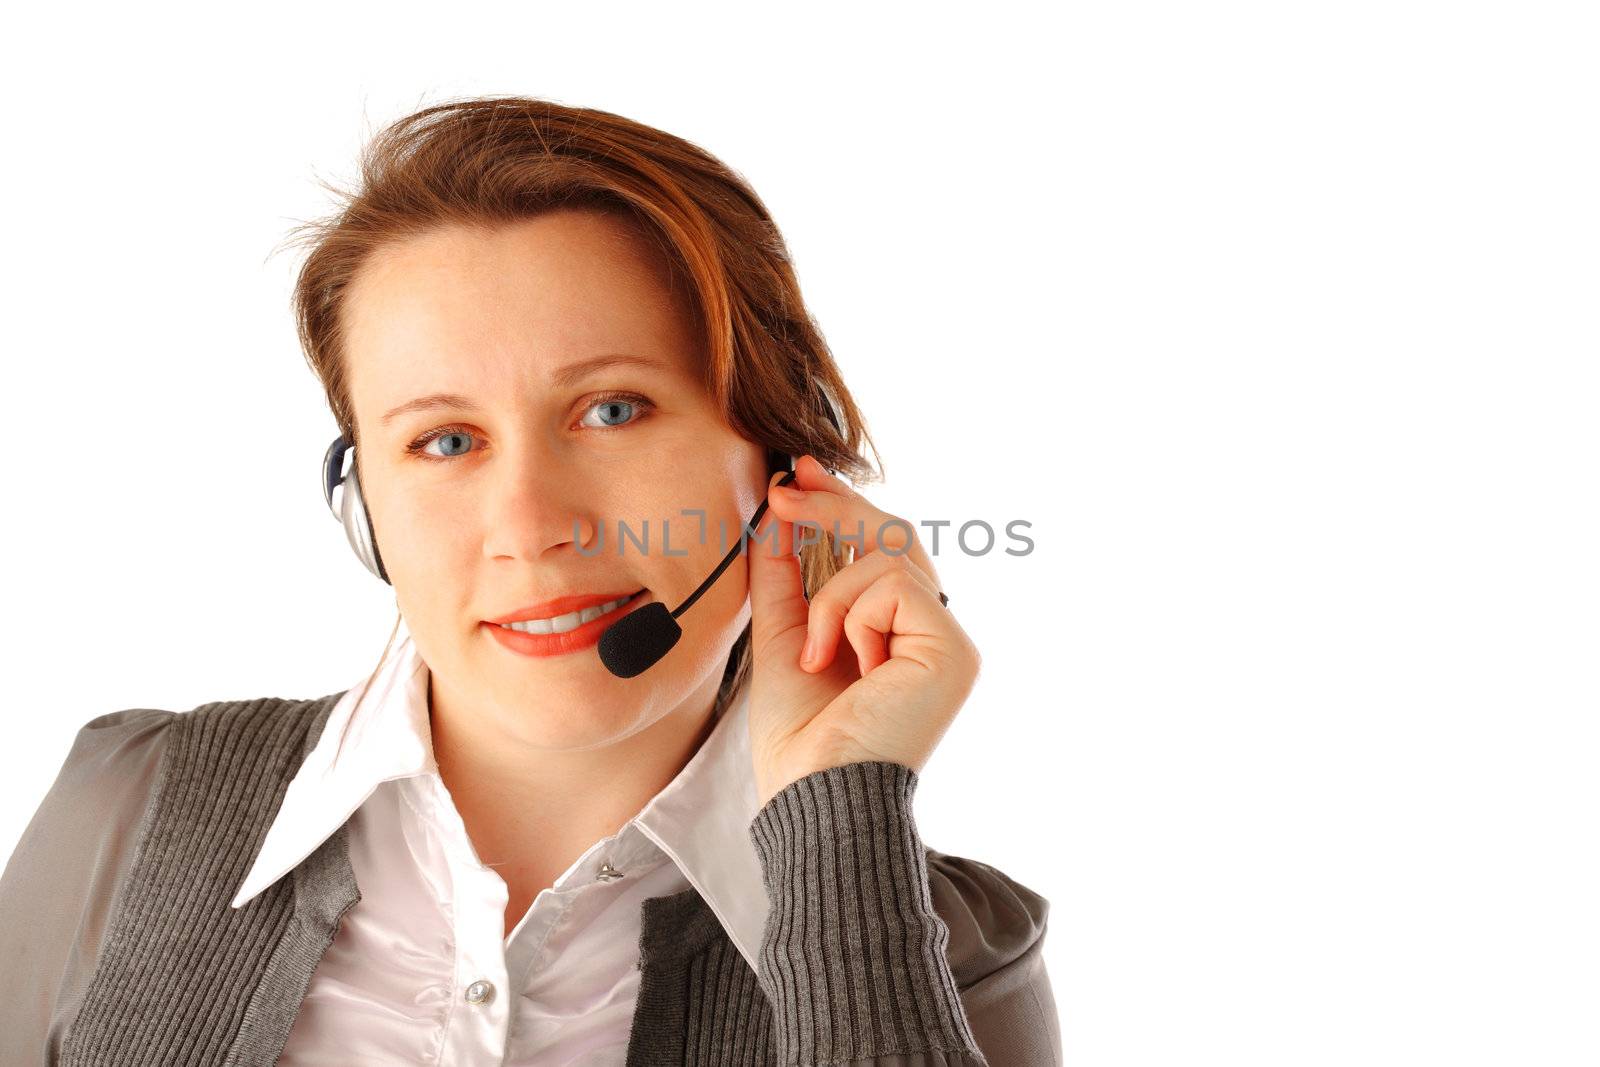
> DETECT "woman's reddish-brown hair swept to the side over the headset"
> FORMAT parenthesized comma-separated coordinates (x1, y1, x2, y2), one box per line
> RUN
(273, 96, 882, 717)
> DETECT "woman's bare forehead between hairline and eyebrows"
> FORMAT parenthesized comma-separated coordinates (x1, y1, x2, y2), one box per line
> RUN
(341, 210, 701, 408)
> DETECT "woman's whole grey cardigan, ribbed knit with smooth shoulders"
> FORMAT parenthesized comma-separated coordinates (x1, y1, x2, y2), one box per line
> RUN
(0, 691, 1061, 1067)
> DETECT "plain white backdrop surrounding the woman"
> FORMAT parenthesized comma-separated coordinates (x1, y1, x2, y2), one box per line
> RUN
(0, 0, 1600, 1067)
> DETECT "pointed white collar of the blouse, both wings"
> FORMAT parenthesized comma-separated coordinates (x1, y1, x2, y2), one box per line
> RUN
(230, 621, 768, 969)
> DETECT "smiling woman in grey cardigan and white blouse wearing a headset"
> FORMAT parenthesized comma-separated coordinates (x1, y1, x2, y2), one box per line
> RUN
(0, 98, 1059, 1065)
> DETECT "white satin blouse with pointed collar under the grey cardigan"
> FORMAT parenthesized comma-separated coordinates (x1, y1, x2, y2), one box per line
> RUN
(232, 622, 768, 1067)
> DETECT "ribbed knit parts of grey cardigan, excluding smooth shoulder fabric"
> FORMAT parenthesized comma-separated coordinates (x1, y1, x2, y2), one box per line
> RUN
(61, 693, 986, 1067)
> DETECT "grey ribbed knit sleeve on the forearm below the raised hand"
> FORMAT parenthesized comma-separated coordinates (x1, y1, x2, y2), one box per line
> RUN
(750, 761, 987, 1067)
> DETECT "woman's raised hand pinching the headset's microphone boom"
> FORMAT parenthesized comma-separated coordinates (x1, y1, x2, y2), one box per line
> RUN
(746, 456, 981, 806)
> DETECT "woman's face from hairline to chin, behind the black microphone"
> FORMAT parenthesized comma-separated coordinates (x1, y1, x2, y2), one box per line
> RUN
(344, 210, 768, 749)
